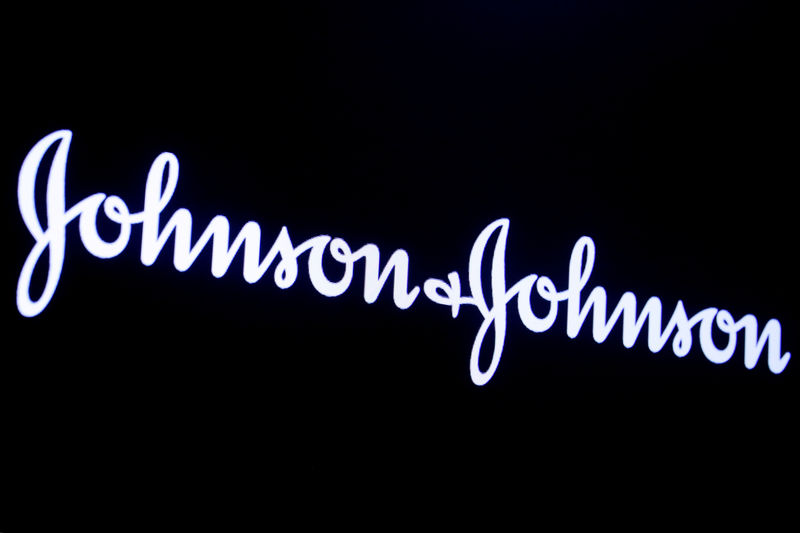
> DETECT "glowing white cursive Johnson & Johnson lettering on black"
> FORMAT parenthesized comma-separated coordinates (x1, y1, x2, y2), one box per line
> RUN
(17, 130, 791, 385)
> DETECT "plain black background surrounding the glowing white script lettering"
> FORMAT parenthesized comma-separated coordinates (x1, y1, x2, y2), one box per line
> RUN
(0, 1, 798, 531)
